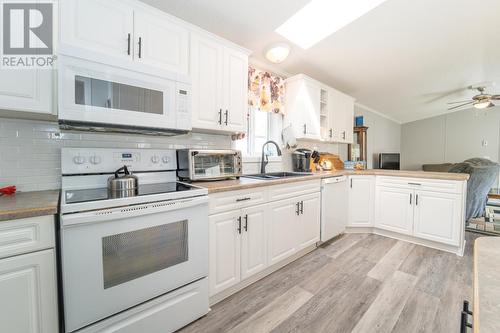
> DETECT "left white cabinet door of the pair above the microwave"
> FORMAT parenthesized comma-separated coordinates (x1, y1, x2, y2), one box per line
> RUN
(59, 0, 134, 61)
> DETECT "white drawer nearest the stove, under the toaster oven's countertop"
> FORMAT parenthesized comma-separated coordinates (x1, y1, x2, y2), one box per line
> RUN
(208, 187, 267, 215)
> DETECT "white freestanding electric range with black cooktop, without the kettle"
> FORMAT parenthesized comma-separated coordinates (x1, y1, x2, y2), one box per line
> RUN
(59, 148, 209, 332)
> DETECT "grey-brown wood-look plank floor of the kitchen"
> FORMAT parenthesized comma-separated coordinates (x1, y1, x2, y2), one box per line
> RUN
(180, 233, 478, 333)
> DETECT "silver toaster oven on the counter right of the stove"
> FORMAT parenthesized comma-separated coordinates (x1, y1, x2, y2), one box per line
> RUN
(177, 149, 242, 181)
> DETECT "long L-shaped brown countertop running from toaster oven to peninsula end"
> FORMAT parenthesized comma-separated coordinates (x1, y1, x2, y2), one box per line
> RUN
(193, 169, 469, 193)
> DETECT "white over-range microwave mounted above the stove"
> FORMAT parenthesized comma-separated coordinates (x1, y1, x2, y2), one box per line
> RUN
(58, 56, 191, 135)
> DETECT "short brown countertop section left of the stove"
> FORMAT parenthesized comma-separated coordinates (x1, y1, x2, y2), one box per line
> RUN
(0, 190, 59, 221)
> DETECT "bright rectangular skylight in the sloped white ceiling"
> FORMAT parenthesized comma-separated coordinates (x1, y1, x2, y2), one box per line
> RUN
(275, 0, 385, 49)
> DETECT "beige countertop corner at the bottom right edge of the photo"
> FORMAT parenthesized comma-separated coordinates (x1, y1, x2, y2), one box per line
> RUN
(472, 237, 500, 333)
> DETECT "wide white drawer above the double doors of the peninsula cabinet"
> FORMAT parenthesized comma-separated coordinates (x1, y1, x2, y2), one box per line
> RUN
(377, 176, 463, 193)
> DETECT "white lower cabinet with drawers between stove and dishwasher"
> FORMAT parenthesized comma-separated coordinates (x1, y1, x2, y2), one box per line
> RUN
(209, 182, 321, 296)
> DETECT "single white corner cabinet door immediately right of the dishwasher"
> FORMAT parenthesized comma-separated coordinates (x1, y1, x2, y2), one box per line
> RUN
(348, 176, 375, 227)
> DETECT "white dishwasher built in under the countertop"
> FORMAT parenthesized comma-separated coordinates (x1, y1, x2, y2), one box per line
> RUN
(321, 176, 348, 242)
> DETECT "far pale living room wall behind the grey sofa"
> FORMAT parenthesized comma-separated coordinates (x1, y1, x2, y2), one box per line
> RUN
(401, 107, 500, 170)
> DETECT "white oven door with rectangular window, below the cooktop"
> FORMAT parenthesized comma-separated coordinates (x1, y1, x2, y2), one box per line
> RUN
(61, 196, 208, 332)
